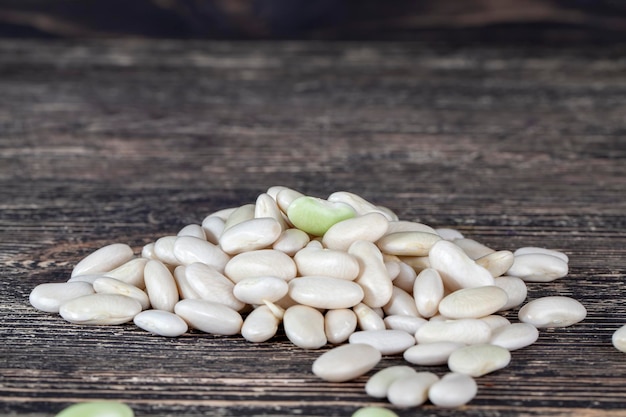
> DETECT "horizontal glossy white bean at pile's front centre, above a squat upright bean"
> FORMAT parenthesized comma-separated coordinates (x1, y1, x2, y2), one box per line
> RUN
(289, 276, 363, 309)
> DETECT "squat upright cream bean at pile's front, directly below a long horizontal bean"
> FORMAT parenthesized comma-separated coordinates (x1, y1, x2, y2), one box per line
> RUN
(283, 305, 327, 349)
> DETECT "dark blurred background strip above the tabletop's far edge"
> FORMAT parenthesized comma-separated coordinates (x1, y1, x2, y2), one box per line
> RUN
(0, 0, 626, 43)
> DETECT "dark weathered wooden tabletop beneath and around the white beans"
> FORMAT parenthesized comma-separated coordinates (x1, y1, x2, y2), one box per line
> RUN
(0, 41, 626, 417)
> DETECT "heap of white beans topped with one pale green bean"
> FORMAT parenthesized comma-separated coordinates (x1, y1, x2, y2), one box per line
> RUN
(30, 186, 592, 411)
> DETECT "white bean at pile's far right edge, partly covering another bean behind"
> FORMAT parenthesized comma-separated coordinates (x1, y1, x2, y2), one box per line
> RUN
(507, 253, 568, 282)
